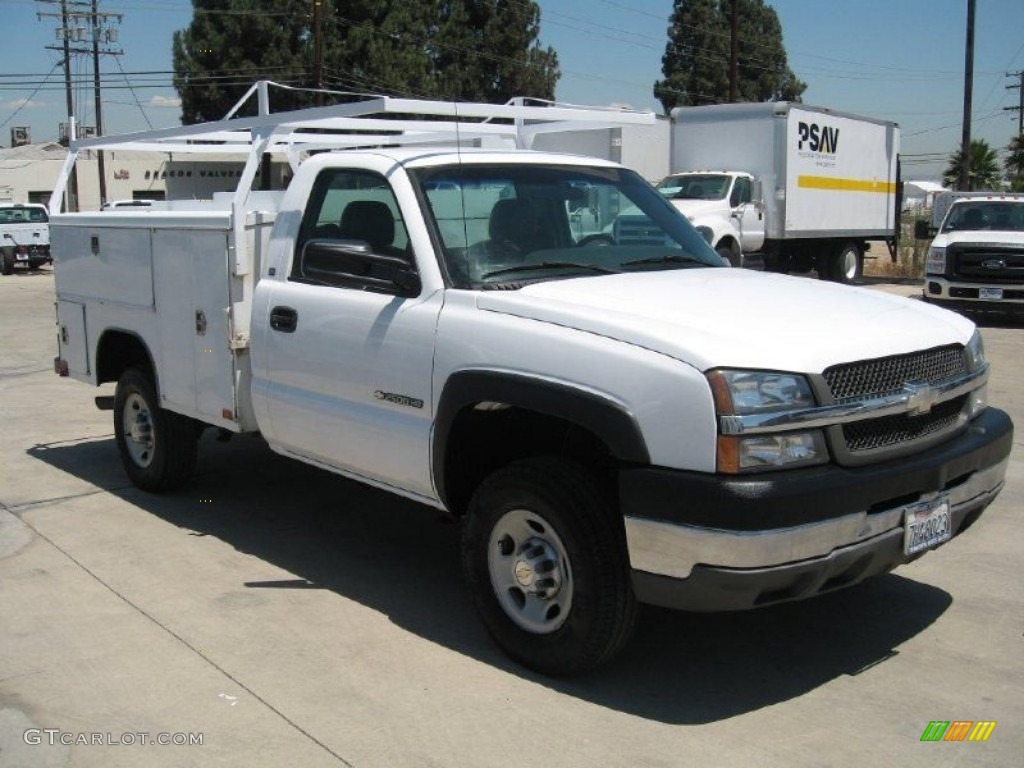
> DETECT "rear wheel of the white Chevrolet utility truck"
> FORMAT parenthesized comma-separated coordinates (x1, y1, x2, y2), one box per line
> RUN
(114, 368, 199, 494)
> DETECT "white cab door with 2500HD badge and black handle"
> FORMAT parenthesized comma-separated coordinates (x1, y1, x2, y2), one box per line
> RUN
(254, 168, 443, 499)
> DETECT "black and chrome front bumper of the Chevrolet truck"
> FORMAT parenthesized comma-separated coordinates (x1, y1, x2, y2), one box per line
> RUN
(621, 409, 1013, 610)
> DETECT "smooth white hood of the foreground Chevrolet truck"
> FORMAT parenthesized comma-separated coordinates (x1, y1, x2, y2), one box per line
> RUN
(477, 268, 974, 373)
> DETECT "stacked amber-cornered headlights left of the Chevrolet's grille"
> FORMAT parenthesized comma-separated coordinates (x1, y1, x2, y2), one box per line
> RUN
(708, 371, 828, 473)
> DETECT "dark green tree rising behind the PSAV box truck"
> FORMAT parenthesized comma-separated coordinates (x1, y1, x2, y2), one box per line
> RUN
(654, 0, 807, 114)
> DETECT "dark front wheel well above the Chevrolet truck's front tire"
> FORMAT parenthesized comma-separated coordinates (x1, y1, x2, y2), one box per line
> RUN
(444, 402, 617, 516)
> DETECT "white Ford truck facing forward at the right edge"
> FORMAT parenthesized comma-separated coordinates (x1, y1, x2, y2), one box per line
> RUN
(914, 191, 1024, 315)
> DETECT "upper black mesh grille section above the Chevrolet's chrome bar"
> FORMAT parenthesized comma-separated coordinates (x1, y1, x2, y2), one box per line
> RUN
(824, 344, 967, 402)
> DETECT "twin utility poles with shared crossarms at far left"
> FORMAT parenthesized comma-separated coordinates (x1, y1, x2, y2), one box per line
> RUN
(36, 0, 124, 211)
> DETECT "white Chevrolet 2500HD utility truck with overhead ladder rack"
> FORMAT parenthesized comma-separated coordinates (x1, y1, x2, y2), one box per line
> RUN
(52, 88, 1013, 675)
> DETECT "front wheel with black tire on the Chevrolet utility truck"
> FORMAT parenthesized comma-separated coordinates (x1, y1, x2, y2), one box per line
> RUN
(462, 458, 637, 676)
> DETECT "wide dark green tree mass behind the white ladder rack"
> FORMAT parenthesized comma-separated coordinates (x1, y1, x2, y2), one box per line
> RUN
(173, 0, 559, 123)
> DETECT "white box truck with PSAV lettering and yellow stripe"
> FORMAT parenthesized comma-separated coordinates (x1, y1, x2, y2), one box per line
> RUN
(659, 101, 900, 283)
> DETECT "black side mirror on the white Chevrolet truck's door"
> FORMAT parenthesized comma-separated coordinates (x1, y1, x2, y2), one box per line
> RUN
(297, 240, 422, 297)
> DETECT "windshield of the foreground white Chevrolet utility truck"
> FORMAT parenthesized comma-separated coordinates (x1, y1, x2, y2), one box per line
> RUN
(414, 164, 722, 289)
